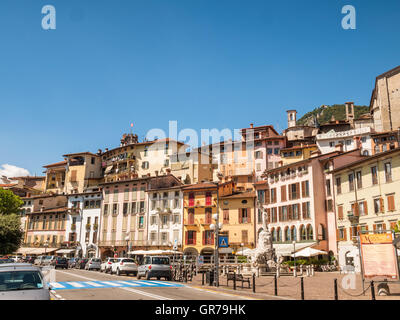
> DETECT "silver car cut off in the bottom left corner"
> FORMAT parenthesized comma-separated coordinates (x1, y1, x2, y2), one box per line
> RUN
(0, 263, 51, 300)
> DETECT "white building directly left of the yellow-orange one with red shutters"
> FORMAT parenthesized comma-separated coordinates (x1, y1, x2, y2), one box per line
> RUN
(146, 174, 183, 251)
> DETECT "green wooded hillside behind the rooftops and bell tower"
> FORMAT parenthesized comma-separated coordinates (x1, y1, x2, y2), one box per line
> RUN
(297, 104, 369, 125)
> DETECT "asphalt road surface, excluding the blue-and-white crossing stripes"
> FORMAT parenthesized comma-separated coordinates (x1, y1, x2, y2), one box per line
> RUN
(50, 269, 256, 300)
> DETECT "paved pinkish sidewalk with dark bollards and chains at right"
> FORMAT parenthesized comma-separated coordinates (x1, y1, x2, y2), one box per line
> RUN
(187, 272, 400, 300)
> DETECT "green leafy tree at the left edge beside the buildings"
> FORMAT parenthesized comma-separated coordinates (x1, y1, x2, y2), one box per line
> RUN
(0, 188, 23, 254)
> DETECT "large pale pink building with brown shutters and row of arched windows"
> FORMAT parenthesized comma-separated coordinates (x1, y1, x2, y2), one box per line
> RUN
(256, 150, 366, 255)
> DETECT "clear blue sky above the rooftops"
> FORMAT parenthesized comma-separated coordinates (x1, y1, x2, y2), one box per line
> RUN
(0, 0, 400, 174)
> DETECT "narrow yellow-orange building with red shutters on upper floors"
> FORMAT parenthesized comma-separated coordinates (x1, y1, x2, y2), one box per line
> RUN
(182, 182, 234, 257)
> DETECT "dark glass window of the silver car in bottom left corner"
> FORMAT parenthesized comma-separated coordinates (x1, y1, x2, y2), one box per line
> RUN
(0, 271, 43, 291)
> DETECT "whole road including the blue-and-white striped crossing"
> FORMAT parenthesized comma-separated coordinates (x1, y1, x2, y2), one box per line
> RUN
(53, 269, 258, 300)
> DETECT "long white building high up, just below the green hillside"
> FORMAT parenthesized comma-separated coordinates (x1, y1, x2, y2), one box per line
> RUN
(316, 127, 374, 155)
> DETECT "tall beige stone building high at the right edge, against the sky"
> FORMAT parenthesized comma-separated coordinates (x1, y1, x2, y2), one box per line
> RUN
(369, 66, 400, 132)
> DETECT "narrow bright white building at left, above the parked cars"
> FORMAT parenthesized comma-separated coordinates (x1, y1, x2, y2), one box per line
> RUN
(65, 189, 102, 257)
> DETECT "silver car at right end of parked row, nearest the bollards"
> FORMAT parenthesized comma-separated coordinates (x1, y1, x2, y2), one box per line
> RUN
(137, 256, 172, 280)
